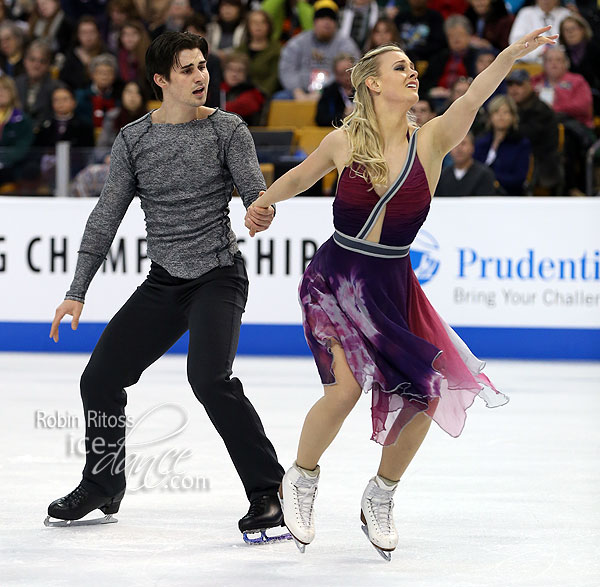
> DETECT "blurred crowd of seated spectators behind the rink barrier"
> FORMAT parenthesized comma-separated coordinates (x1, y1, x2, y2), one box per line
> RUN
(0, 0, 600, 196)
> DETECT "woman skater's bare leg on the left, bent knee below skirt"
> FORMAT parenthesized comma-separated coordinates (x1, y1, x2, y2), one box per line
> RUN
(296, 343, 361, 471)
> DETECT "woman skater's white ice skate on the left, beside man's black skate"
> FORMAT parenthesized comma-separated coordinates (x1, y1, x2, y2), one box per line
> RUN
(281, 463, 321, 552)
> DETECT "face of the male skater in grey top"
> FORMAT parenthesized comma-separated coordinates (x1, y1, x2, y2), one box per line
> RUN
(159, 49, 209, 108)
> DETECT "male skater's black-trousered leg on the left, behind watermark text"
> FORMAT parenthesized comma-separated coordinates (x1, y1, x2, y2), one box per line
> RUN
(81, 276, 187, 496)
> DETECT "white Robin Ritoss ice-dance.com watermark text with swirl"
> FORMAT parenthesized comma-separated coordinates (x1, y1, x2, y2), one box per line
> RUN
(34, 403, 210, 491)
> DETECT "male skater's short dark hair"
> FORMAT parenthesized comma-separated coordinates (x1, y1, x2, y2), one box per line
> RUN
(146, 32, 208, 100)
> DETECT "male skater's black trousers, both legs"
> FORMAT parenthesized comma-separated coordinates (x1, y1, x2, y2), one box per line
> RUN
(81, 253, 283, 499)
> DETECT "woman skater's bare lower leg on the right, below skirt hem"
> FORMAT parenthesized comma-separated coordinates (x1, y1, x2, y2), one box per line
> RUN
(377, 412, 431, 481)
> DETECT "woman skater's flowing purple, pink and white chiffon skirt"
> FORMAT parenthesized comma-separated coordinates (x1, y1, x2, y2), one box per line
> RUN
(299, 239, 508, 446)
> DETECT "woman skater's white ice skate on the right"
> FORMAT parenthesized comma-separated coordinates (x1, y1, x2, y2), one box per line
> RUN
(360, 476, 398, 562)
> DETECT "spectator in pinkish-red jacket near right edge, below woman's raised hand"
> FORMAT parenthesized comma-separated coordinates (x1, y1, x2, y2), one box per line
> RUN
(531, 45, 594, 128)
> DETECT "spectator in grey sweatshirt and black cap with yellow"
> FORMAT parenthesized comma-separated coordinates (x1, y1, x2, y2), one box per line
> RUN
(274, 0, 360, 100)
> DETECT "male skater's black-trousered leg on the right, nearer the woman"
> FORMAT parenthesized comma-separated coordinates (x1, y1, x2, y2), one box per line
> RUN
(187, 257, 283, 500)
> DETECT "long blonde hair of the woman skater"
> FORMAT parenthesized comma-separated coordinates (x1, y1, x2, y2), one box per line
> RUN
(340, 45, 416, 186)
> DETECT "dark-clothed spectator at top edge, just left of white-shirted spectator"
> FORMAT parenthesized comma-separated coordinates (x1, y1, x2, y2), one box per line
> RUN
(465, 0, 515, 51)
